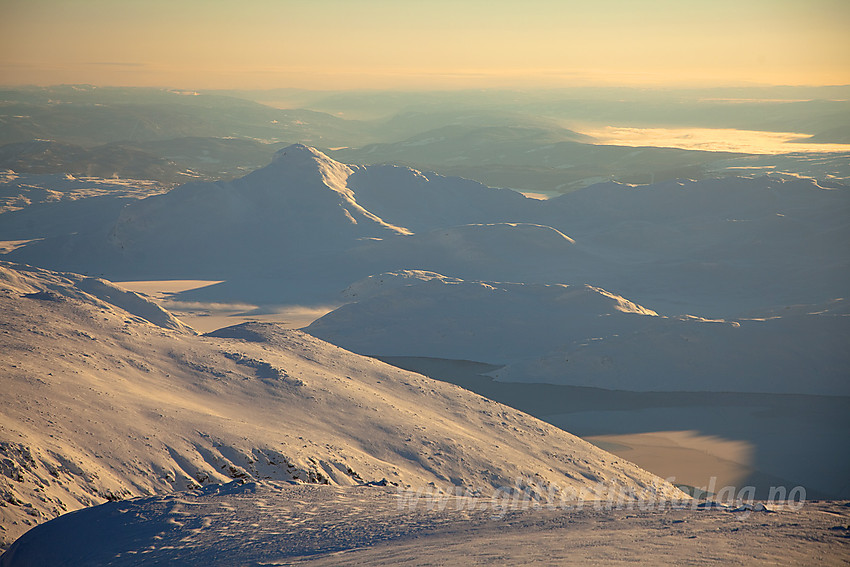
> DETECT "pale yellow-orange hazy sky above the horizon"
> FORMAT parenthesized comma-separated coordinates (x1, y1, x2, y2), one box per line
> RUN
(0, 0, 850, 89)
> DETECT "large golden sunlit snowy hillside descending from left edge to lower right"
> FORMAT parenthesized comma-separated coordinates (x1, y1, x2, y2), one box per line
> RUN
(0, 263, 682, 545)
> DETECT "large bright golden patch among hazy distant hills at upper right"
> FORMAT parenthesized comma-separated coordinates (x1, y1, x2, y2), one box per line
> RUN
(582, 126, 850, 154)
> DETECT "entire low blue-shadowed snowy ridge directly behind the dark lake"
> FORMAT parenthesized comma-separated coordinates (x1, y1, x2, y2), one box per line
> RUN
(305, 271, 850, 395)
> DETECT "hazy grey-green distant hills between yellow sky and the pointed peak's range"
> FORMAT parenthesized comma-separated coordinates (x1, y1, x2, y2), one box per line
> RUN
(0, 85, 850, 195)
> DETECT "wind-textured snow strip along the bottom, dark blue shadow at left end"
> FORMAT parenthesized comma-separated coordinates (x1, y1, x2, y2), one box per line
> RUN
(0, 481, 850, 567)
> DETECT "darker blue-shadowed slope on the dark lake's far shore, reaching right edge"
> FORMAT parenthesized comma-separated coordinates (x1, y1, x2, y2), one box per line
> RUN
(491, 302, 850, 396)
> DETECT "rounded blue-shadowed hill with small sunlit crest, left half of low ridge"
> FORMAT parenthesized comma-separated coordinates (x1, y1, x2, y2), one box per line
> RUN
(305, 272, 656, 364)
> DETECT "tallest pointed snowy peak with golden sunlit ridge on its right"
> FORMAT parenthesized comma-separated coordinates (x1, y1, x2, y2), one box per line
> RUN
(94, 144, 410, 278)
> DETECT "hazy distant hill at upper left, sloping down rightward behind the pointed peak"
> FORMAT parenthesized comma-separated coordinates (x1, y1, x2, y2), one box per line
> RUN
(0, 85, 360, 147)
